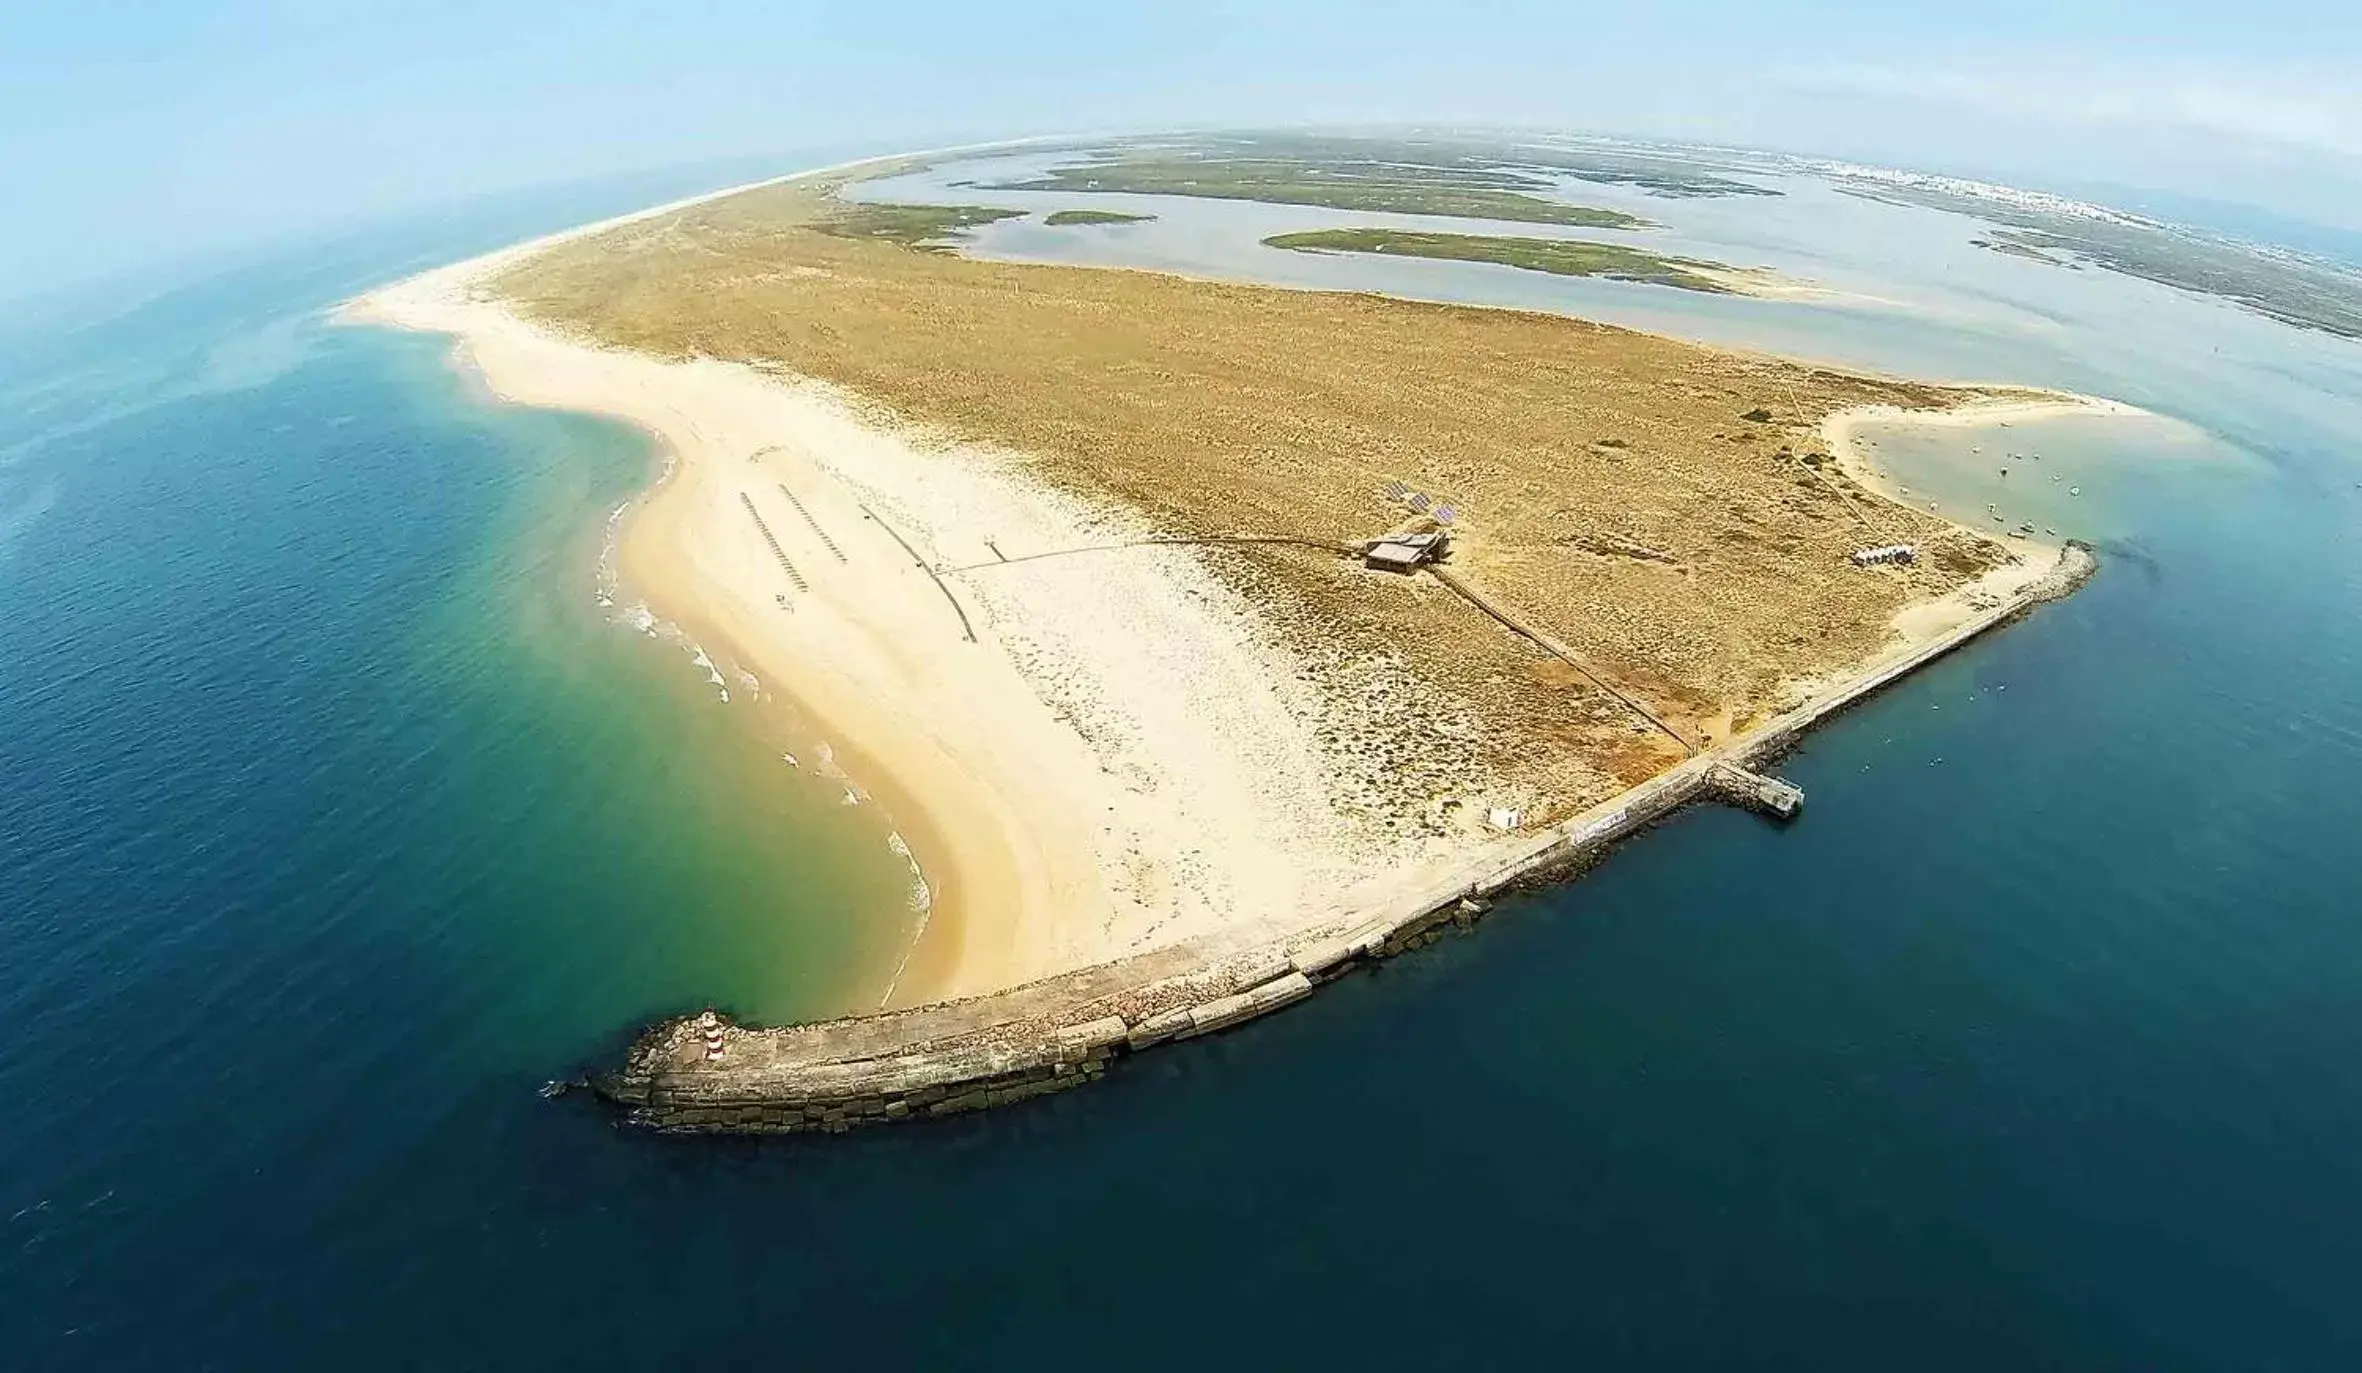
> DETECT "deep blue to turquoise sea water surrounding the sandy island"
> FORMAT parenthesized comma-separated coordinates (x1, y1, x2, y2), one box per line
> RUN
(0, 144, 2362, 1371)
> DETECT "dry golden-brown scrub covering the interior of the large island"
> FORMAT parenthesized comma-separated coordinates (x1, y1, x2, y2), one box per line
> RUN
(496, 182, 2008, 825)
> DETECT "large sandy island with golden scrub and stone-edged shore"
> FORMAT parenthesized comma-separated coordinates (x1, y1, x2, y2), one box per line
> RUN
(345, 144, 2093, 1132)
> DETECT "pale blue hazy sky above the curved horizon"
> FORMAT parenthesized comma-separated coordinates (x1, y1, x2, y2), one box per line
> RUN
(0, 0, 2362, 298)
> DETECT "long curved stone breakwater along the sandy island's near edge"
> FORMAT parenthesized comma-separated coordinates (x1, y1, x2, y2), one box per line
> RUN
(591, 544, 2095, 1134)
